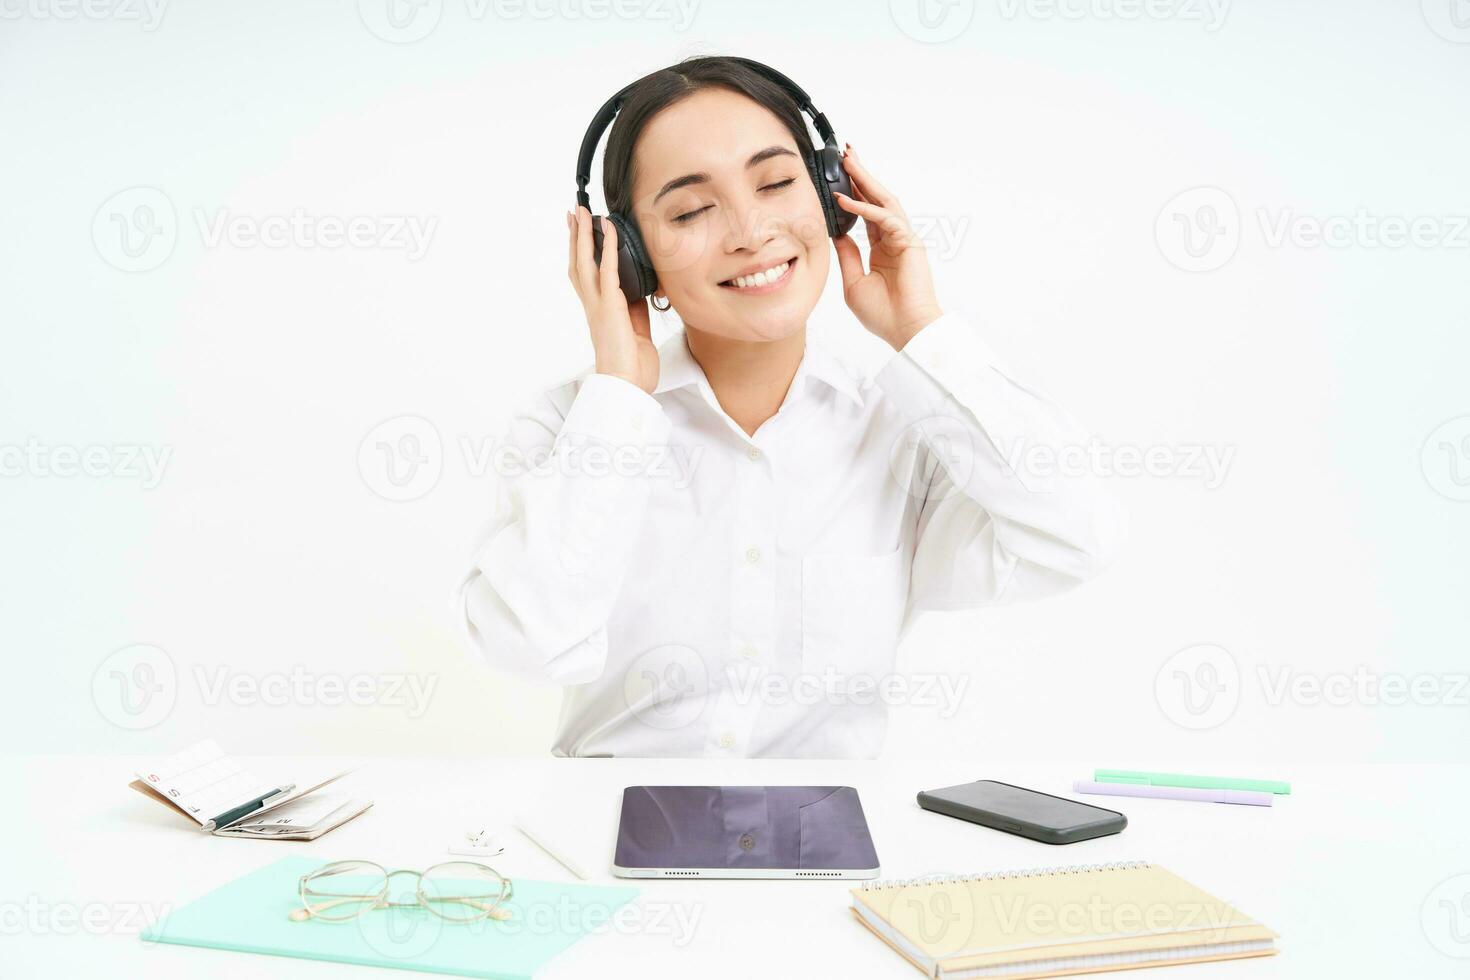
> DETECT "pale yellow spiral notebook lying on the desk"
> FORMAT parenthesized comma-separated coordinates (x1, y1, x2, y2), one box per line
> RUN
(851, 861, 1277, 980)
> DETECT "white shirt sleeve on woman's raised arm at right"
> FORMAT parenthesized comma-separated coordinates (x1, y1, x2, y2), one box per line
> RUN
(875, 313, 1126, 610)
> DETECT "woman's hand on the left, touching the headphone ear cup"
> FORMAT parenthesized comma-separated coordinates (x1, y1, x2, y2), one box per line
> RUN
(566, 204, 659, 394)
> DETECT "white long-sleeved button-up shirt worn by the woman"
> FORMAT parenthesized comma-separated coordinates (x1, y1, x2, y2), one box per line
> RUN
(454, 313, 1125, 758)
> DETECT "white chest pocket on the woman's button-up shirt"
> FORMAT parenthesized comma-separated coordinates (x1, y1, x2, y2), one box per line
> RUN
(801, 545, 908, 680)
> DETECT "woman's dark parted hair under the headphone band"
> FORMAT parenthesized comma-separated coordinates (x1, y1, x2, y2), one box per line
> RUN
(603, 54, 813, 220)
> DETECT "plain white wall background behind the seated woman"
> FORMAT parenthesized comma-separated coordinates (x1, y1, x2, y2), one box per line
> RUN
(0, 0, 1470, 764)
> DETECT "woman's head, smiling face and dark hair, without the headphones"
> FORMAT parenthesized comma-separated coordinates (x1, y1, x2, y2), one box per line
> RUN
(579, 57, 856, 358)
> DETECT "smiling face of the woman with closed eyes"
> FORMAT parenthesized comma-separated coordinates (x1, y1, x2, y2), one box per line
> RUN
(632, 88, 831, 341)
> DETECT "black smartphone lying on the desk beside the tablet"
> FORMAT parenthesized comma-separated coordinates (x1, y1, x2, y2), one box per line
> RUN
(919, 779, 1127, 843)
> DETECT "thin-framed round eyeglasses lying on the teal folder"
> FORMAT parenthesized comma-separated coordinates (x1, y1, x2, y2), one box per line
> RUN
(290, 861, 512, 923)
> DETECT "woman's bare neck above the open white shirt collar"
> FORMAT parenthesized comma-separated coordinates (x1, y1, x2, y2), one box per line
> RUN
(684, 325, 807, 435)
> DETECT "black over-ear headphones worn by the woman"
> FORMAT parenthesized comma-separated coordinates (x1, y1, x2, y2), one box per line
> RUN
(576, 57, 857, 309)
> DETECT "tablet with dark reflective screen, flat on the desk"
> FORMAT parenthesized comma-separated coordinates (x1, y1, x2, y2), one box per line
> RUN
(613, 786, 878, 879)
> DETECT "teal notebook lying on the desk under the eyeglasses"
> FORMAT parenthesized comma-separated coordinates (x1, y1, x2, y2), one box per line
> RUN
(143, 857, 638, 980)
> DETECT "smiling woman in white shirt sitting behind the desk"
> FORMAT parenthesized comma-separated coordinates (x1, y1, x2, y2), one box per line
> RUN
(456, 57, 1122, 757)
